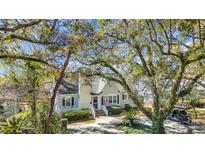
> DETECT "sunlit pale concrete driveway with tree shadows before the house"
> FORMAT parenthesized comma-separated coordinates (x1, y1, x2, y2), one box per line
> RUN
(67, 116, 205, 134)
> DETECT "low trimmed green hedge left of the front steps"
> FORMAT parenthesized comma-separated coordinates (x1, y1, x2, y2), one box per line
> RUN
(62, 109, 92, 121)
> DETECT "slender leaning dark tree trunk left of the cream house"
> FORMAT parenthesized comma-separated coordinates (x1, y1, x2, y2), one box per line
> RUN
(44, 51, 71, 134)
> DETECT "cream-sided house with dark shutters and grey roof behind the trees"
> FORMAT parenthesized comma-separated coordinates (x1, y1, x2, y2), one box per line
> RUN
(54, 77, 134, 115)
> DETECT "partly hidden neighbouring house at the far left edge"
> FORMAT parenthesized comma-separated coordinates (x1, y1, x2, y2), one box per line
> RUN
(0, 84, 19, 118)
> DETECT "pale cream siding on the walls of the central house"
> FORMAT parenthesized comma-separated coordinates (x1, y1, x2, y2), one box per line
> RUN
(55, 78, 135, 113)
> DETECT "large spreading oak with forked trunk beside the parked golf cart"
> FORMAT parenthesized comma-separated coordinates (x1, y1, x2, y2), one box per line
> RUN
(77, 20, 205, 133)
